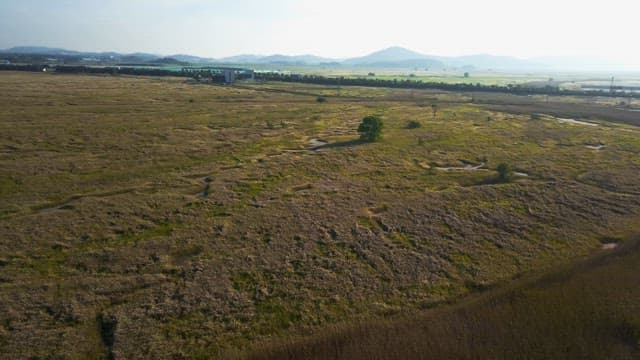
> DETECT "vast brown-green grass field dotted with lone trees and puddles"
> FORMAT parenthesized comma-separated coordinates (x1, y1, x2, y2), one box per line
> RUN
(0, 73, 640, 359)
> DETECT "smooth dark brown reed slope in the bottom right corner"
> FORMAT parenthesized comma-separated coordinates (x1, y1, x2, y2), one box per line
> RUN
(247, 239, 640, 360)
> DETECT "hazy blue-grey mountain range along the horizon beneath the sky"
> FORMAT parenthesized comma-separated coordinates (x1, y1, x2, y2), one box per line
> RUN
(0, 46, 624, 71)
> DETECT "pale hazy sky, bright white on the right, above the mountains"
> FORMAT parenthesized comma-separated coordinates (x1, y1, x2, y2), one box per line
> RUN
(0, 0, 640, 64)
